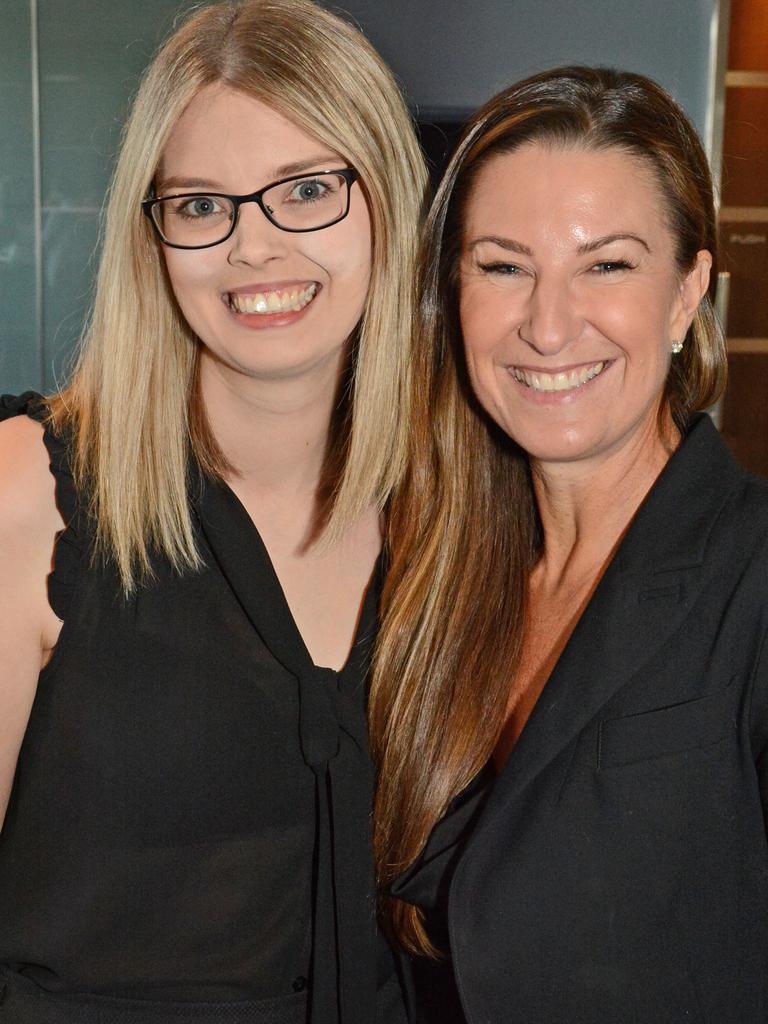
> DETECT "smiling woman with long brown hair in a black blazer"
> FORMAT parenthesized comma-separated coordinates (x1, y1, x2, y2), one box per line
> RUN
(371, 68, 768, 1024)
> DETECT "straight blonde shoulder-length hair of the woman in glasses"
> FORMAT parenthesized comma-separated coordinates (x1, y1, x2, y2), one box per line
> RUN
(49, 0, 426, 592)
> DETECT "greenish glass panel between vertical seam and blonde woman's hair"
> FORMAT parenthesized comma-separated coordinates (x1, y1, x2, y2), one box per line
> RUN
(36, 0, 190, 387)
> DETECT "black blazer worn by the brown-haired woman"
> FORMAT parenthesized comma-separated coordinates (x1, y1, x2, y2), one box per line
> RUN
(392, 417, 768, 1024)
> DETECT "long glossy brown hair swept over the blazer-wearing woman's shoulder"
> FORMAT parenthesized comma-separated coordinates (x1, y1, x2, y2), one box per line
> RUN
(370, 67, 725, 952)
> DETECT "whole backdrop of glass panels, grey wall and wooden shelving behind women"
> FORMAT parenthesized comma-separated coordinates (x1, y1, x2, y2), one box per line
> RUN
(0, 0, 768, 474)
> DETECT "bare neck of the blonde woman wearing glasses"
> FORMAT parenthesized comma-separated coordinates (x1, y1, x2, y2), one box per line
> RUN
(200, 353, 340, 499)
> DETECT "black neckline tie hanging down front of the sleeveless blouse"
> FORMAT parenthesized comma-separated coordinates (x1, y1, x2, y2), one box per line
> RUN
(191, 481, 380, 1024)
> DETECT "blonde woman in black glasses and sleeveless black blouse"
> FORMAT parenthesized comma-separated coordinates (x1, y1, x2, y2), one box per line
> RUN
(0, 0, 424, 1024)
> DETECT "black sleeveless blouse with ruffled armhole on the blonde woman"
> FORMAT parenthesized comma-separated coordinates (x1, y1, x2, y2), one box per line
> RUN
(0, 394, 397, 1024)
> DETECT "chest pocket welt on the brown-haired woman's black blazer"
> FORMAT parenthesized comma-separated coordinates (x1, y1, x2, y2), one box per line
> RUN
(577, 683, 733, 771)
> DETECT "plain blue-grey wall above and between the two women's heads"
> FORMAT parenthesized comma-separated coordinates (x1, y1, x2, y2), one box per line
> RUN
(329, 0, 720, 132)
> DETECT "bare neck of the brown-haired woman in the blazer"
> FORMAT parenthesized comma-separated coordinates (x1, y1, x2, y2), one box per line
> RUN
(531, 407, 680, 586)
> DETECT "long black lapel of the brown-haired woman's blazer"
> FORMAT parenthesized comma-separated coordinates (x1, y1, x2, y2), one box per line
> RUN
(470, 415, 743, 846)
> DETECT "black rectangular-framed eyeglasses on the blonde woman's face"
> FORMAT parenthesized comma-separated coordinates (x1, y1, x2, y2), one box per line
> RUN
(141, 167, 358, 249)
